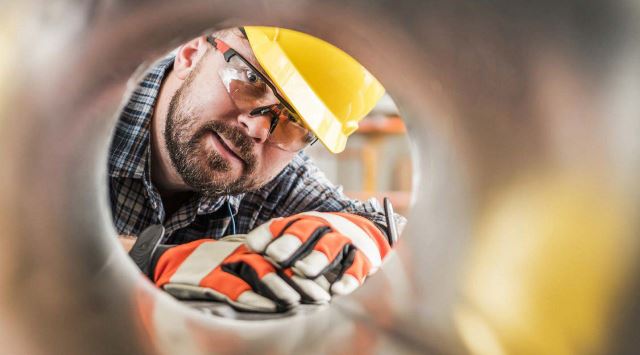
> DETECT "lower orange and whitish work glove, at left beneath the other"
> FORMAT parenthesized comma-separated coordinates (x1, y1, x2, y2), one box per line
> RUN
(150, 236, 300, 312)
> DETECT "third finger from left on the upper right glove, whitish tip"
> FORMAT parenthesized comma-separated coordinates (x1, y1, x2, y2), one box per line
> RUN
(293, 233, 351, 279)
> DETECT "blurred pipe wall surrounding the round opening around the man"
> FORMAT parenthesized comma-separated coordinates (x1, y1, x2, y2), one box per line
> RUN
(0, 0, 640, 354)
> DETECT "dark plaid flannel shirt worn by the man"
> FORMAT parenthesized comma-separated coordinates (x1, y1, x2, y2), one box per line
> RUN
(108, 56, 405, 244)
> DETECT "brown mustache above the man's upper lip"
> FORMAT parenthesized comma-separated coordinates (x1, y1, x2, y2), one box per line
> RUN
(190, 121, 257, 174)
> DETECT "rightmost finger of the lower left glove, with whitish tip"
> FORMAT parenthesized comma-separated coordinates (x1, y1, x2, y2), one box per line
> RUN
(222, 253, 300, 308)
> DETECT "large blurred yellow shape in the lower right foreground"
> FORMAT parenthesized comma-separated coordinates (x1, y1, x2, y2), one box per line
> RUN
(455, 177, 636, 355)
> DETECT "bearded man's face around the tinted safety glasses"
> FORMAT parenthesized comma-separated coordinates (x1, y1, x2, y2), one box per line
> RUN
(164, 34, 295, 196)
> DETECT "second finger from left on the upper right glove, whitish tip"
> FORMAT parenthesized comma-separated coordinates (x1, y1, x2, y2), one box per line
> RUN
(264, 219, 331, 268)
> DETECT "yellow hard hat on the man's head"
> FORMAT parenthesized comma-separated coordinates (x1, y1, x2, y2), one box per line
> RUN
(244, 27, 384, 153)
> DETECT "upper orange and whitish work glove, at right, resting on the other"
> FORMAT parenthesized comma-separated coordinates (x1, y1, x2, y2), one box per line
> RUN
(246, 212, 391, 303)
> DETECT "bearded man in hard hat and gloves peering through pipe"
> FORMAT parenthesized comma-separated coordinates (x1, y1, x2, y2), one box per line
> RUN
(109, 27, 404, 312)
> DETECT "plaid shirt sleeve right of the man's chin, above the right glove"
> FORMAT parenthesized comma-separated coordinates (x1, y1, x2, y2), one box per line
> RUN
(238, 152, 406, 233)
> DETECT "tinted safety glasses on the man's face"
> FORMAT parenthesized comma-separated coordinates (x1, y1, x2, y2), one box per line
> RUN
(207, 36, 317, 152)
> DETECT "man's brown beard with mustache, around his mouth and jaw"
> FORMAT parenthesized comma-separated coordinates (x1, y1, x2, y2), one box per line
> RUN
(164, 68, 263, 197)
